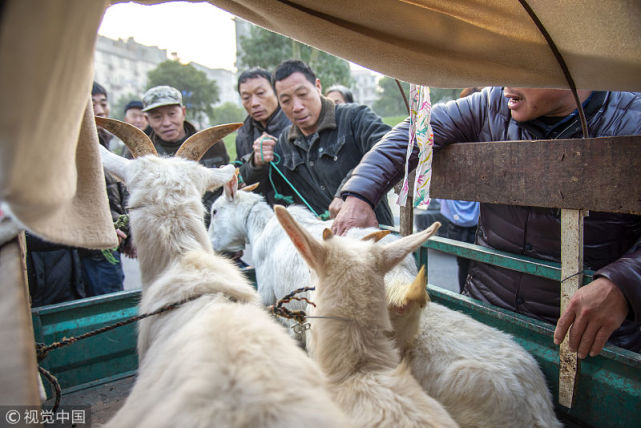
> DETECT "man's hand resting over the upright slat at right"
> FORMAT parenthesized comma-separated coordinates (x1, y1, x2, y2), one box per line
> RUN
(554, 278, 628, 359)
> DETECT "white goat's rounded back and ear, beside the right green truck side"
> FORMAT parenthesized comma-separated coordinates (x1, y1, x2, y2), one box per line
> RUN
(387, 267, 562, 428)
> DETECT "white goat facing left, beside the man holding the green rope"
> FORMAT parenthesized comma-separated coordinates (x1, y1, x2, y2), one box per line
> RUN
(209, 180, 417, 320)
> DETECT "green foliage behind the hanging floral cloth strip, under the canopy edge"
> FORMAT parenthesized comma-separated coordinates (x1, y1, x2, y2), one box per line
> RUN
(373, 76, 461, 116)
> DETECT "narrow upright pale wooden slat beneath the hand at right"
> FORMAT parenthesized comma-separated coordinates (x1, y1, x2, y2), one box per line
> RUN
(559, 209, 584, 408)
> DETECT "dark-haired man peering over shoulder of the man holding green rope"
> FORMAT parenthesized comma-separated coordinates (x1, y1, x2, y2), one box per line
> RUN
(236, 68, 291, 205)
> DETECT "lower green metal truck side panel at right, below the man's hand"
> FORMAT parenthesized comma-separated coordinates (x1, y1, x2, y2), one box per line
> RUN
(428, 285, 641, 427)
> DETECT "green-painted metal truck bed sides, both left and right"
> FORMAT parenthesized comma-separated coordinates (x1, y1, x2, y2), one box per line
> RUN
(32, 252, 641, 427)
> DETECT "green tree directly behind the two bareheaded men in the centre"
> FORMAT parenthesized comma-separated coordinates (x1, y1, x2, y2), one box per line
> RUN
(238, 26, 351, 88)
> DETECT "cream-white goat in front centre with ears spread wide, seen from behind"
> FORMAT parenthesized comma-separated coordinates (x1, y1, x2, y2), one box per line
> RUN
(274, 206, 457, 427)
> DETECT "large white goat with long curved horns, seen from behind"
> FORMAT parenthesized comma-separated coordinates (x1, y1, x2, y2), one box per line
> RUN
(101, 118, 345, 428)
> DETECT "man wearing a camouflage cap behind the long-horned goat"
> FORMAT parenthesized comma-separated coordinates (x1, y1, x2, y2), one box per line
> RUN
(142, 86, 229, 226)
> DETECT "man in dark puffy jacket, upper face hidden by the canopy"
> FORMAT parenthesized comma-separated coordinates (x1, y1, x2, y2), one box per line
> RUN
(333, 87, 641, 358)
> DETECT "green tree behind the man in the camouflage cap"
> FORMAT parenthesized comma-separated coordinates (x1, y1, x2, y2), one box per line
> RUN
(147, 61, 219, 122)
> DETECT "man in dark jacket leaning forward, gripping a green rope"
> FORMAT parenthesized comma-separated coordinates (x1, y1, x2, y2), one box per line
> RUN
(245, 60, 393, 225)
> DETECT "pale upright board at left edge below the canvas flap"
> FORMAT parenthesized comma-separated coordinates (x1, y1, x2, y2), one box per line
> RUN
(0, 232, 40, 406)
